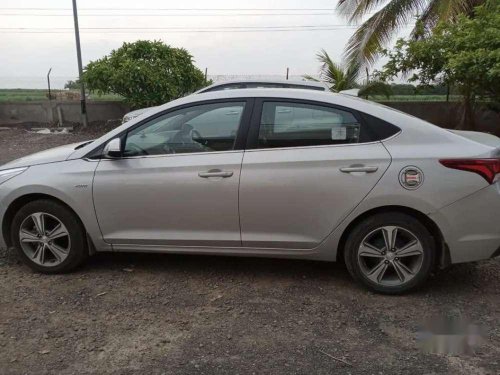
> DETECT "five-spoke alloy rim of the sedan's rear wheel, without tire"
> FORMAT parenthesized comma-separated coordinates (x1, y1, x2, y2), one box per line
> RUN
(357, 226, 424, 286)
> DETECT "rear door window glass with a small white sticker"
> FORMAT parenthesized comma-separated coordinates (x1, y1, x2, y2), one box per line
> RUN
(258, 102, 363, 148)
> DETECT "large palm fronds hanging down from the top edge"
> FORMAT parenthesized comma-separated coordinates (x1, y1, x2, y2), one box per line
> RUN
(337, 0, 488, 64)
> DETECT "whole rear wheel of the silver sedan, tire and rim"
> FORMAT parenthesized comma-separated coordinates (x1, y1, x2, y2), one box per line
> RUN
(344, 212, 435, 294)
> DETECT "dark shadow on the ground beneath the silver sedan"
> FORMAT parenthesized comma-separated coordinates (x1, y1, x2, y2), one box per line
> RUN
(0, 250, 490, 296)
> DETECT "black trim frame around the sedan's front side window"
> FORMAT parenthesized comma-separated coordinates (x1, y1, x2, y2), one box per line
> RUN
(83, 97, 255, 160)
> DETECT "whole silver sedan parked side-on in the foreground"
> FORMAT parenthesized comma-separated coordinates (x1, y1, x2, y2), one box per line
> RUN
(0, 89, 500, 294)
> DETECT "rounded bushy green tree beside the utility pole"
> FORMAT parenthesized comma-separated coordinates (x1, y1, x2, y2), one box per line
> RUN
(83, 40, 206, 108)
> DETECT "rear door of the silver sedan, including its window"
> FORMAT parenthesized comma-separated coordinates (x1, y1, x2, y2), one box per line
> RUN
(240, 99, 391, 249)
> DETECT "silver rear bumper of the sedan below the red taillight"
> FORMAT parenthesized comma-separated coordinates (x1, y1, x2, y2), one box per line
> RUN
(429, 182, 500, 263)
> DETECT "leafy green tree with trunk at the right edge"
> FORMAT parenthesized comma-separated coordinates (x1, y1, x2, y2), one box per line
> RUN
(378, 2, 500, 129)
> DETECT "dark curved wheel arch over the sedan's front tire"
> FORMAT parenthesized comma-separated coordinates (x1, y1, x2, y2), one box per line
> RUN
(1, 193, 95, 255)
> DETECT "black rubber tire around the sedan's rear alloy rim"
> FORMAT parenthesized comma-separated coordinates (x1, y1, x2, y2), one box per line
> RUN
(344, 212, 436, 294)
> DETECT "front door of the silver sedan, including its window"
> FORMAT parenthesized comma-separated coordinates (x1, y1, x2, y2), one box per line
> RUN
(93, 99, 251, 247)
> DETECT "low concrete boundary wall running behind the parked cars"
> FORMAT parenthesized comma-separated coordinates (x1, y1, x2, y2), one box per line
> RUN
(0, 101, 500, 135)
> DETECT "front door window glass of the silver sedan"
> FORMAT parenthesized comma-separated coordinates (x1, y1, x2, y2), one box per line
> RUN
(124, 102, 245, 156)
